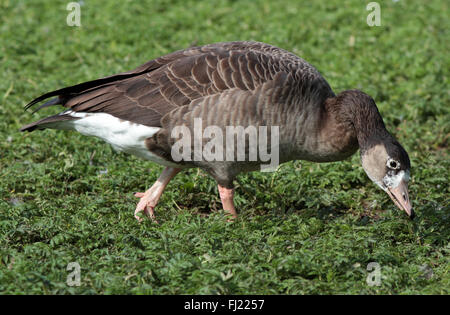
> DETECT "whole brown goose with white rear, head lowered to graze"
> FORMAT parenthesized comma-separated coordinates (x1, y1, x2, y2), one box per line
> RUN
(21, 41, 414, 221)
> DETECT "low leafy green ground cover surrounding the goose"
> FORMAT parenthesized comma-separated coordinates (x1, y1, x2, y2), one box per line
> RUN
(0, 0, 450, 294)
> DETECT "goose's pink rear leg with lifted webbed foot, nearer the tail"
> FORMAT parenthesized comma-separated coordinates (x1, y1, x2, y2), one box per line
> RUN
(134, 167, 181, 222)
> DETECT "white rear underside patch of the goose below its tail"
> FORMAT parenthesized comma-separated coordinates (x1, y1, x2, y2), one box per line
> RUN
(53, 110, 179, 167)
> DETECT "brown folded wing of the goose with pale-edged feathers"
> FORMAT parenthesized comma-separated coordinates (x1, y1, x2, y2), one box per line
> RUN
(26, 42, 333, 127)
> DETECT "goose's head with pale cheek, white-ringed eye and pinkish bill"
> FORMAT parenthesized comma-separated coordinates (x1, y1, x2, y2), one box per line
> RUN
(361, 139, 414, 219)
